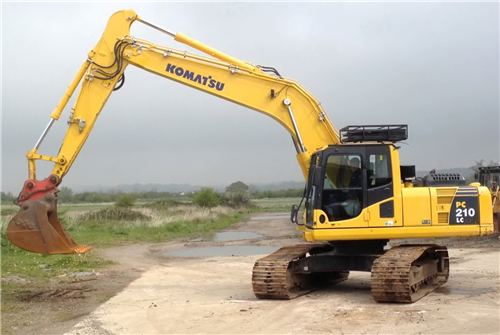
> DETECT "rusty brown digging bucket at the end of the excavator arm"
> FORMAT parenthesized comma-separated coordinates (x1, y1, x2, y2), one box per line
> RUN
(7, 193, 91, 255)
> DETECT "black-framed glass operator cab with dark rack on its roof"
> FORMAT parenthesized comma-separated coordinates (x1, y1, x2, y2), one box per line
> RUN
(300, 125, 408, 225)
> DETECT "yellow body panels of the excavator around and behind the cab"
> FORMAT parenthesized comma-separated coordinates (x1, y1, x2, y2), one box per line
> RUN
(299, 147, 493, 241)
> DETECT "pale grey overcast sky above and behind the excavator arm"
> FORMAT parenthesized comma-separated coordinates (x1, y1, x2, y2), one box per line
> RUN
(1, 2, 500, 194)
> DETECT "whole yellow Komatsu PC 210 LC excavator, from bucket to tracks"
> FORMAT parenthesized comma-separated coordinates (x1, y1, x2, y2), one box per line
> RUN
(7, 10, 493, 303)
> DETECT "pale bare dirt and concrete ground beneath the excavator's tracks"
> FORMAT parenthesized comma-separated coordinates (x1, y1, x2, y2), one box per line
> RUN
(4, 214, 500, 335)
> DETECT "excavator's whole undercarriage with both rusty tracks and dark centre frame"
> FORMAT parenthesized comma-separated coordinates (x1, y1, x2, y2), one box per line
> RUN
(252, 240, 449, 303)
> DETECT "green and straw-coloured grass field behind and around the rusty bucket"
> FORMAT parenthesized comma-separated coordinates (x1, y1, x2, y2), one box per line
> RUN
(1, 198, 300, 282)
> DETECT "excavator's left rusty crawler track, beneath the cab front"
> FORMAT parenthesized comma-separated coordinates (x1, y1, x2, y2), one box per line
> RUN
(252, 244, 349, 299)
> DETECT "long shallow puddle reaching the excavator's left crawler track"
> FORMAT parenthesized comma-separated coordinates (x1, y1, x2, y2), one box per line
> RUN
(163, 245, 279, 257)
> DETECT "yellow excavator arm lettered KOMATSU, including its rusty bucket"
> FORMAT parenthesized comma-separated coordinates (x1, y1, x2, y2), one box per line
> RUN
(7, 10, 340, 254)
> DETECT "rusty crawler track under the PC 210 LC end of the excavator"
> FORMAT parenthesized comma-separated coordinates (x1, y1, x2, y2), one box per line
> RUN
(371, 245, 449, 303)
